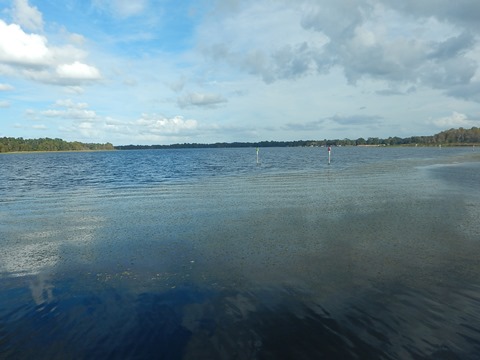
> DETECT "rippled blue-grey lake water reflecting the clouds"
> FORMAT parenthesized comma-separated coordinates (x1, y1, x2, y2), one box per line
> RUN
(0, 147, 480, 359)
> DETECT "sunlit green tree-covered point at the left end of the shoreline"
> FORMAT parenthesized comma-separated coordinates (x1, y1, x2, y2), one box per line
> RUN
(0, 137, 115, 153)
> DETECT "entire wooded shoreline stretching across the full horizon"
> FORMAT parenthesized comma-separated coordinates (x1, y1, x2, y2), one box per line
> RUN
(0, 127, 480, 153)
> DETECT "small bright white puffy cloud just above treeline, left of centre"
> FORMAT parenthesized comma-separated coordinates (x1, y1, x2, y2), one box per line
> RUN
(135, 114, 198, 135)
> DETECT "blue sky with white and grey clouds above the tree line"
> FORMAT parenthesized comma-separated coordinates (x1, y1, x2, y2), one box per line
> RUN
(0, 0, 480, 145)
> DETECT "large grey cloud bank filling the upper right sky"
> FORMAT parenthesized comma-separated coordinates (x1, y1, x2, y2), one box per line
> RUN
(199, 0, 480, 102)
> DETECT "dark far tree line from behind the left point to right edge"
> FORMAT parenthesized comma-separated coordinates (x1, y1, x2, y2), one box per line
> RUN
(115, 127, 480, 150)
